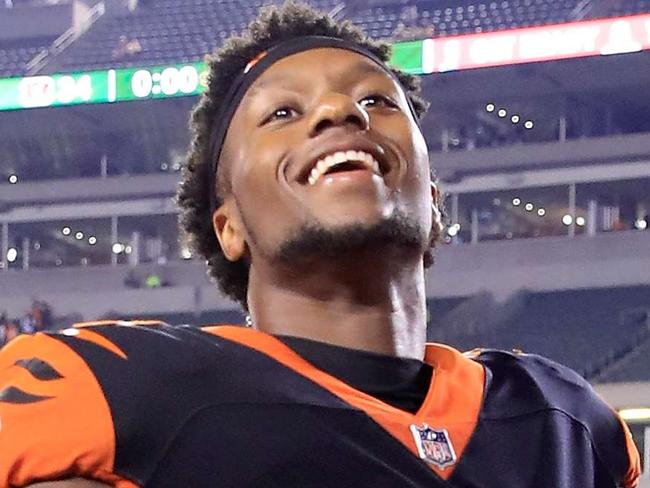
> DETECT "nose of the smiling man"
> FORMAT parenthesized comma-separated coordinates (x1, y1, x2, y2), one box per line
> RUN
(309, 93, 370, 137)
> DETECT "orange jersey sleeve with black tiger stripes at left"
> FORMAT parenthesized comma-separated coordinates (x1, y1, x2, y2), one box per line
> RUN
(0, 333, 137, 488)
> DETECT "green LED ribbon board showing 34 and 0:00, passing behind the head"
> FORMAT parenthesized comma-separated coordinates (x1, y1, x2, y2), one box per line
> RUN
(0, 41, 422, 110)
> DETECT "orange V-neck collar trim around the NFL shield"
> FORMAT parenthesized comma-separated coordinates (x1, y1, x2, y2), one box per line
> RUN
(202, 326, 485, 479)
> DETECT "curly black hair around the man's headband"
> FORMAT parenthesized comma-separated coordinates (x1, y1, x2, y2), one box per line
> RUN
(177, 2, 437, 310)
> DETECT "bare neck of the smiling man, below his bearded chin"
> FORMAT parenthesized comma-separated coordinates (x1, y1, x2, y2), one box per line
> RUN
(248, 250, 426, 359)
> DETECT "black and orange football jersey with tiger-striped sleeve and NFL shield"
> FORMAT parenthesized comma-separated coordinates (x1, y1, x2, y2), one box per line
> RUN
(0, 323, 639, 488)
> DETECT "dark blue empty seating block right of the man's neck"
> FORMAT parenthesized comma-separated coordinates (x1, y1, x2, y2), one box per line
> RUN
(429, 286, 650, 381)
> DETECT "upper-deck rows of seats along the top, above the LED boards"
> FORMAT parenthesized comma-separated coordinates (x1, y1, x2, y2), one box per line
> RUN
(5, 0, 650, 76)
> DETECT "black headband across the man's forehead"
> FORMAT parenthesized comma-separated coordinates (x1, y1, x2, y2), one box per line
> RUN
(208, 36, 418, 213)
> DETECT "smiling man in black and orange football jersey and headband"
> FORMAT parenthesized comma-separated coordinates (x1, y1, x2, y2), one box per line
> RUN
(0, 1, 639, 488)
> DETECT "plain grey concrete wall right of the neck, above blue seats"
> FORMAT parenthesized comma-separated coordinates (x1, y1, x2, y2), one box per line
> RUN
(427, 231, 650, 300)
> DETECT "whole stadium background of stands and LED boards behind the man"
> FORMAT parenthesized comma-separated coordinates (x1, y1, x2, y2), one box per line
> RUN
(0, 0, 650, 486)
